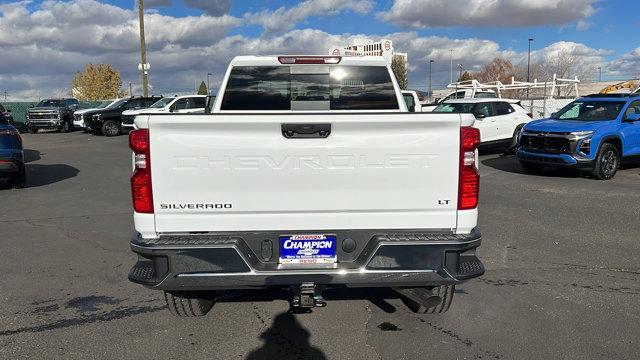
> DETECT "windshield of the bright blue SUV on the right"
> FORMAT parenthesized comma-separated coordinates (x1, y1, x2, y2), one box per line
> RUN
(551, 100, 626, 121)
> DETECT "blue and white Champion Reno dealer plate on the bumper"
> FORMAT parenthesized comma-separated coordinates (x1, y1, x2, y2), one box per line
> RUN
(280, 234, 336, 264)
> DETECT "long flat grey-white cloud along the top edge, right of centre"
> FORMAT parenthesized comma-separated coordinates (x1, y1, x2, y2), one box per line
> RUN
(378, 0, 599, 28)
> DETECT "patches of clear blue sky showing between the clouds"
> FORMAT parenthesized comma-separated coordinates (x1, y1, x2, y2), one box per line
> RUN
(115, 0, 640, 58)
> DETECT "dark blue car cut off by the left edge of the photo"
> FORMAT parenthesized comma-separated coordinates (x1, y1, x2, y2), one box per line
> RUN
(0, 113, 26, 188)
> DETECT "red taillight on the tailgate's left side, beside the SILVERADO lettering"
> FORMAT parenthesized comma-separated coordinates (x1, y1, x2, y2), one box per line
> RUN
(129, 129, 153, 214)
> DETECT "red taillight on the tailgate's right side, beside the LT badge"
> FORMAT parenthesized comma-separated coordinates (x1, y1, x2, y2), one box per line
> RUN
(458, 127, 480, 210)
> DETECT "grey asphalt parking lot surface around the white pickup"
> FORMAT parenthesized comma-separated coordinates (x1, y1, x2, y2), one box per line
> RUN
(0, 132, 640, 359)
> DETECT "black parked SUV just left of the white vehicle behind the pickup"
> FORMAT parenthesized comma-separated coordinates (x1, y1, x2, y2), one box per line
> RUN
(83, 96, 162, 136)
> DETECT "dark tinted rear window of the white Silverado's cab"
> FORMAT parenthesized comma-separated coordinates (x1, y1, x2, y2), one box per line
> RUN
(220, 65, 399, 111)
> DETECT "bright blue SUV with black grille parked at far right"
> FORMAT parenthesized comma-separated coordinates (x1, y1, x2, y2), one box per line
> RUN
(517, 94, 640, 180)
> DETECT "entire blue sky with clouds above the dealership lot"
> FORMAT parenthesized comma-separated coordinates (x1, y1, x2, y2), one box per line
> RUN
(0, 0, 640, 97)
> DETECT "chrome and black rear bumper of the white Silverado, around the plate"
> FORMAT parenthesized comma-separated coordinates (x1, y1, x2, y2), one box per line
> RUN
(129, 229, 484, 290)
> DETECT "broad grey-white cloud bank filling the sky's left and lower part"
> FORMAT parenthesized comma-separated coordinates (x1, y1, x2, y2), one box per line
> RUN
(0, 0, 640, 99)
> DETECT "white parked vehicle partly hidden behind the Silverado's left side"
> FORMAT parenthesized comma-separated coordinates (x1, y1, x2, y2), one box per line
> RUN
(122, 95, 207, 131)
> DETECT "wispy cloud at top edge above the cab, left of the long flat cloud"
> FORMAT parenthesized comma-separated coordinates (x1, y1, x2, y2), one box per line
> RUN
(245, 0, 373, 33)
